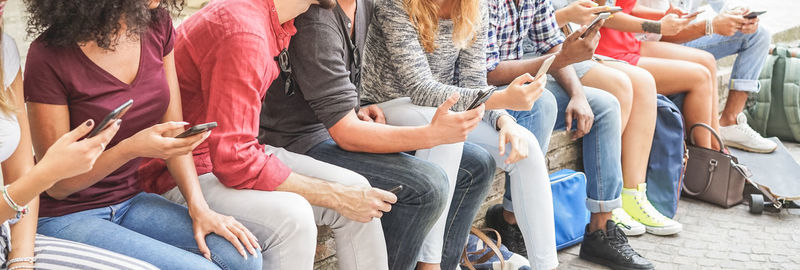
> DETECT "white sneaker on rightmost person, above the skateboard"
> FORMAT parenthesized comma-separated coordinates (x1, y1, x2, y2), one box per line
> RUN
(719, 113, 778, 153)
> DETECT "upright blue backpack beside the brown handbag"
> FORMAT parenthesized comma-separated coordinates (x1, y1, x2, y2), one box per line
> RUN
(647, 95, 688, 218)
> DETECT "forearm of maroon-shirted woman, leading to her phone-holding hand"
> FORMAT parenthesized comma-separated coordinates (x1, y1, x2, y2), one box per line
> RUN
(47, 143, 134, 200)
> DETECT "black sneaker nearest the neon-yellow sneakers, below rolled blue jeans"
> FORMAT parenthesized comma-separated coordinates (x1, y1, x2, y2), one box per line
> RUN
(580, 220, 655, 270)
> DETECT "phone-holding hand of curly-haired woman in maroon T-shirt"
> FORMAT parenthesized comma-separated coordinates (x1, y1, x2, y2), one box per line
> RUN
(120, 122, 211, 159)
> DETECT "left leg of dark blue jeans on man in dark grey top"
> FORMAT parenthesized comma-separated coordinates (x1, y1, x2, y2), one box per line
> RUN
(305, 139, 450, 270)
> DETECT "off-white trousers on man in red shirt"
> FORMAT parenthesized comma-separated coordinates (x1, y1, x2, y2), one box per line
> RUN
(163, 145, 388, 270)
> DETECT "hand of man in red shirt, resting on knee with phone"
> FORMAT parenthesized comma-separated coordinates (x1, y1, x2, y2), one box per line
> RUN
(335, 186, 397, 223)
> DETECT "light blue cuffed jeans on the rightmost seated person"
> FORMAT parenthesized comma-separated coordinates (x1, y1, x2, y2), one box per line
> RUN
(683, 26, 770, 92)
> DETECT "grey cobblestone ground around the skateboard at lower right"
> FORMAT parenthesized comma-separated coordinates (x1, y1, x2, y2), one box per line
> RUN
(558, 143, 800, 269)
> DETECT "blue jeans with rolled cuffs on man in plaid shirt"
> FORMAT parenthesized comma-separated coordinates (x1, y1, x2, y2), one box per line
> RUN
(503, 77, 622, 213)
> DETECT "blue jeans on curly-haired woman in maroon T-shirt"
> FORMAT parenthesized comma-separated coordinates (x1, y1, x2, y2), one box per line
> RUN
(38, 193, 261, 269)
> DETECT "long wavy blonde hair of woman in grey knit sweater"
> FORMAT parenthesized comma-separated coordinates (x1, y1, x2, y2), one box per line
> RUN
(403, 0, 481, 53)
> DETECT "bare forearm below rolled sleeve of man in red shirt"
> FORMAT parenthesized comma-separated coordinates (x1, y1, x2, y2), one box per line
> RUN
(275, 172, 347, 209)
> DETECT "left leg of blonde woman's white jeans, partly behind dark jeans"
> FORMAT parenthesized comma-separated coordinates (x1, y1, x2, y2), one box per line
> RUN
(377, 98, 464, 263)
